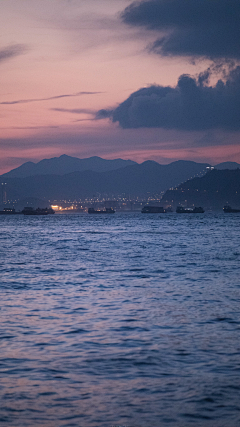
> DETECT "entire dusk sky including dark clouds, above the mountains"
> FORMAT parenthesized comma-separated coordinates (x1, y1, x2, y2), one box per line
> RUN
(0, 0, 240, 174)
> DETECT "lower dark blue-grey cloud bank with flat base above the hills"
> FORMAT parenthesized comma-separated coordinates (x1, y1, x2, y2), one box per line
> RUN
(98, 66, 240, 131)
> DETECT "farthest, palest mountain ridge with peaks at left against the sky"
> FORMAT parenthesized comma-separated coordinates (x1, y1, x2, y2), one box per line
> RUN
(2, 154, 136, 178)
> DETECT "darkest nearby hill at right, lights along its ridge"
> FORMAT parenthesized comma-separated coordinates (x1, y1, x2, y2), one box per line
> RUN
(162, 169, 240, 210)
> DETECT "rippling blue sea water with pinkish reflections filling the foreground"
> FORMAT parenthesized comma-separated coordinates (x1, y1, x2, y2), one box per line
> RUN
(0, 213, 240, 427)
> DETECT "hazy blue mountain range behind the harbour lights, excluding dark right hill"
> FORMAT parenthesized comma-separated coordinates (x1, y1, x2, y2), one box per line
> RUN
(0, 155, 240, 206)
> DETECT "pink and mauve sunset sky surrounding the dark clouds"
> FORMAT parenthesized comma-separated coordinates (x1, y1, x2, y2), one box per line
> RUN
(0, 0, 240, 173)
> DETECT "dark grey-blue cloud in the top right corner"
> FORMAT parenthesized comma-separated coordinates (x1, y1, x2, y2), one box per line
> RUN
(121, 0, 240, 59)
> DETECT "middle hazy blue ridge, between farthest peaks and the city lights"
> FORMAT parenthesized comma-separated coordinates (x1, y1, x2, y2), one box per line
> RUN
(0, 160, 209, 200)
